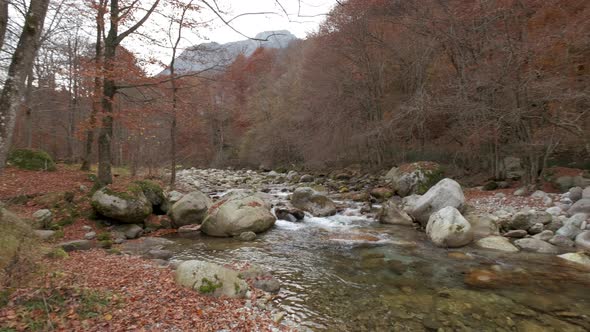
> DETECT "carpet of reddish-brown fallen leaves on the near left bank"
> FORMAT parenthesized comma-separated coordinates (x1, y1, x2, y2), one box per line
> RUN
(0, 250, 282, 331)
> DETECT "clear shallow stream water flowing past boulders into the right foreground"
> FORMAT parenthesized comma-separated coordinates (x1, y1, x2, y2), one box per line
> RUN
(163, 191, 590, 331)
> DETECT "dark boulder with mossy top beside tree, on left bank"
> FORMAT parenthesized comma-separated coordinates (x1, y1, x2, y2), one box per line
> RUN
(91, 186, 152, 224)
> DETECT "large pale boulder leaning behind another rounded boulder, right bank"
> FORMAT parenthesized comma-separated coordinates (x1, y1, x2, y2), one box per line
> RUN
(408, 179, 465, 226)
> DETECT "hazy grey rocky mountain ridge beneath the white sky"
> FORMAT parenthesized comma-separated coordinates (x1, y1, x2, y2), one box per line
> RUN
(160, 30, 297, 75)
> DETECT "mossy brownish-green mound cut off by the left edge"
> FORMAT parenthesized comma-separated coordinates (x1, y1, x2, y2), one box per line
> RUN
(0, 207, 36, 289)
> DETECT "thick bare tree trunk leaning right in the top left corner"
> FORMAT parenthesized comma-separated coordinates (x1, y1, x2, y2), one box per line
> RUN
(0, 0, 49, 171)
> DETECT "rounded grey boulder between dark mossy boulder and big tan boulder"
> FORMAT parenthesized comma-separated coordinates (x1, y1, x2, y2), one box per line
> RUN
(168, 191, 213, 227)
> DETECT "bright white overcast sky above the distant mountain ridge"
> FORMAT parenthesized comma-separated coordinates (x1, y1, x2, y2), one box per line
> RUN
(123, 0, 336, 73)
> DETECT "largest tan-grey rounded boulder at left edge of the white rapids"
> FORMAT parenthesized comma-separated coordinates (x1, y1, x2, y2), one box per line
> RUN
(201, 193, 276, 237)
